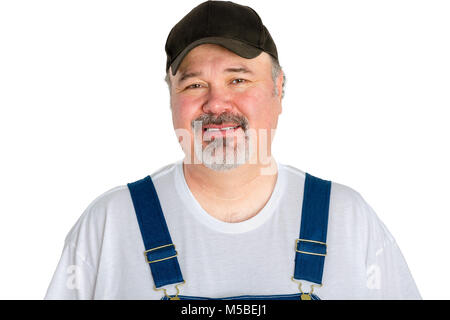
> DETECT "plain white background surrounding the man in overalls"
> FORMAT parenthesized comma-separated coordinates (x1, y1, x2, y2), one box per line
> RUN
(0, 0, 450, 299)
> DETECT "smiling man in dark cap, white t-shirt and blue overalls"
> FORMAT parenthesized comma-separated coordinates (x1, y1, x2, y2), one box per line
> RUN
(46, 1, 420, 300)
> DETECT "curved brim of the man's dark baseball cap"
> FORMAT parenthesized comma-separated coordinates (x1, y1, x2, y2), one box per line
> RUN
(171, 37, 262, 75)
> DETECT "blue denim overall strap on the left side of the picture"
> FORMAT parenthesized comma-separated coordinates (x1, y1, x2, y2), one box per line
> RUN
(128, 176, 184, 288)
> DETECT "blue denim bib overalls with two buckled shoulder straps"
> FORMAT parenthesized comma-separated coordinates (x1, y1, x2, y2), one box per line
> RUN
(128, 173, 331, 300)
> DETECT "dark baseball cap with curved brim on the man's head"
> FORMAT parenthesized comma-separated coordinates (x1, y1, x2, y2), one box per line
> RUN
(166, 1, 278, 75)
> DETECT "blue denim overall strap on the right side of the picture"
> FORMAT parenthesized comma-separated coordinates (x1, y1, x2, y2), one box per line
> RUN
(294, 173, 331, 285)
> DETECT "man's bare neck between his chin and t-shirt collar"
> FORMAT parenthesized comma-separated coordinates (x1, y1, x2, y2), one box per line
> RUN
(183, 158, 278, 222)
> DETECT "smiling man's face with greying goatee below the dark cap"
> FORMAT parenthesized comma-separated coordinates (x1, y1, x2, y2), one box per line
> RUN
(169, 44, 282, 170)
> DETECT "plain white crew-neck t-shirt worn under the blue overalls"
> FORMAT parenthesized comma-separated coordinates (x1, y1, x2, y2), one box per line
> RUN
(45, 160, 421, 299)
